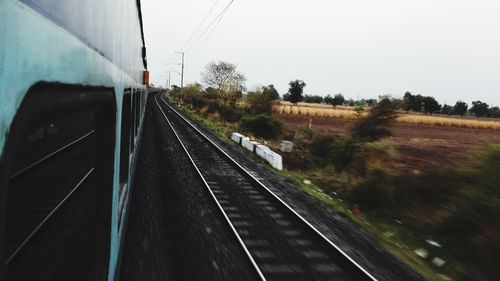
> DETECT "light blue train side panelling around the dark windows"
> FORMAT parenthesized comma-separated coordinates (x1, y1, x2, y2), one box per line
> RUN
(0, 0, 147, 280)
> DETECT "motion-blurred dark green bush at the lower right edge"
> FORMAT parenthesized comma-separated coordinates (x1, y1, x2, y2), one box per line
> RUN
(439, 147, 500, 280)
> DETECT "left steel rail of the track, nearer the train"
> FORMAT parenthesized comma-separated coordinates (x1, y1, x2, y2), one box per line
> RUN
(155, 97, 266, 281)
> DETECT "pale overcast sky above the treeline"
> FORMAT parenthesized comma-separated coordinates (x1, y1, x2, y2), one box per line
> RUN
(142, 0, 500, 106)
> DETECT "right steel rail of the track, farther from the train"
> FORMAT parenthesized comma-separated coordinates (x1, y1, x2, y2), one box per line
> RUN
(160, 97, 377, 281)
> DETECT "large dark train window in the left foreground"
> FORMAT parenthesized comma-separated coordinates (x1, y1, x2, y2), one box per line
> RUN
(0, 84, 115, 280)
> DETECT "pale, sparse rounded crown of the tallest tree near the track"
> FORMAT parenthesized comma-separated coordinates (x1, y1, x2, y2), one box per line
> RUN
(201, 61, 246, 92)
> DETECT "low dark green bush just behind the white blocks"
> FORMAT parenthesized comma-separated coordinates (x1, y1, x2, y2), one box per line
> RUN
(240, 114, 283, 139)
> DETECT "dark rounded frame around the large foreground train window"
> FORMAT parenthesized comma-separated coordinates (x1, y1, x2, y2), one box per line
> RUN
(0, 82, 116, 280)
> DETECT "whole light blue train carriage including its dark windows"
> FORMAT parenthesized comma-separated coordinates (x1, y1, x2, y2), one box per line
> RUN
(0, 0, 147, 280)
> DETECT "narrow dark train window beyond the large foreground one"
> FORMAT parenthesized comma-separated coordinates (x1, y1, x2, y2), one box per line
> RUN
(118, 89, 132, 223)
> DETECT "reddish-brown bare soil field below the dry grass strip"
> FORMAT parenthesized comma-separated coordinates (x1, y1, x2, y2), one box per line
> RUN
(279, 115, 500, 170)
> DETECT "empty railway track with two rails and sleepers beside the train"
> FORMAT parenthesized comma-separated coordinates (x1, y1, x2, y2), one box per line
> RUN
(156, 94, 376, 280)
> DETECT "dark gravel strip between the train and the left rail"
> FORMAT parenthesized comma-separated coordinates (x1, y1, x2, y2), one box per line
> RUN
(120, 97, 258, 281)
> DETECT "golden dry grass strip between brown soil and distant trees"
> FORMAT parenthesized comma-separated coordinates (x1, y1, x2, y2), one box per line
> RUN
(275, 102, 500, 129)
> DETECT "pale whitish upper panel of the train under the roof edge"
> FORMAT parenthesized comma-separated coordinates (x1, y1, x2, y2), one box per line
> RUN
(20, 0, 145, 76)
